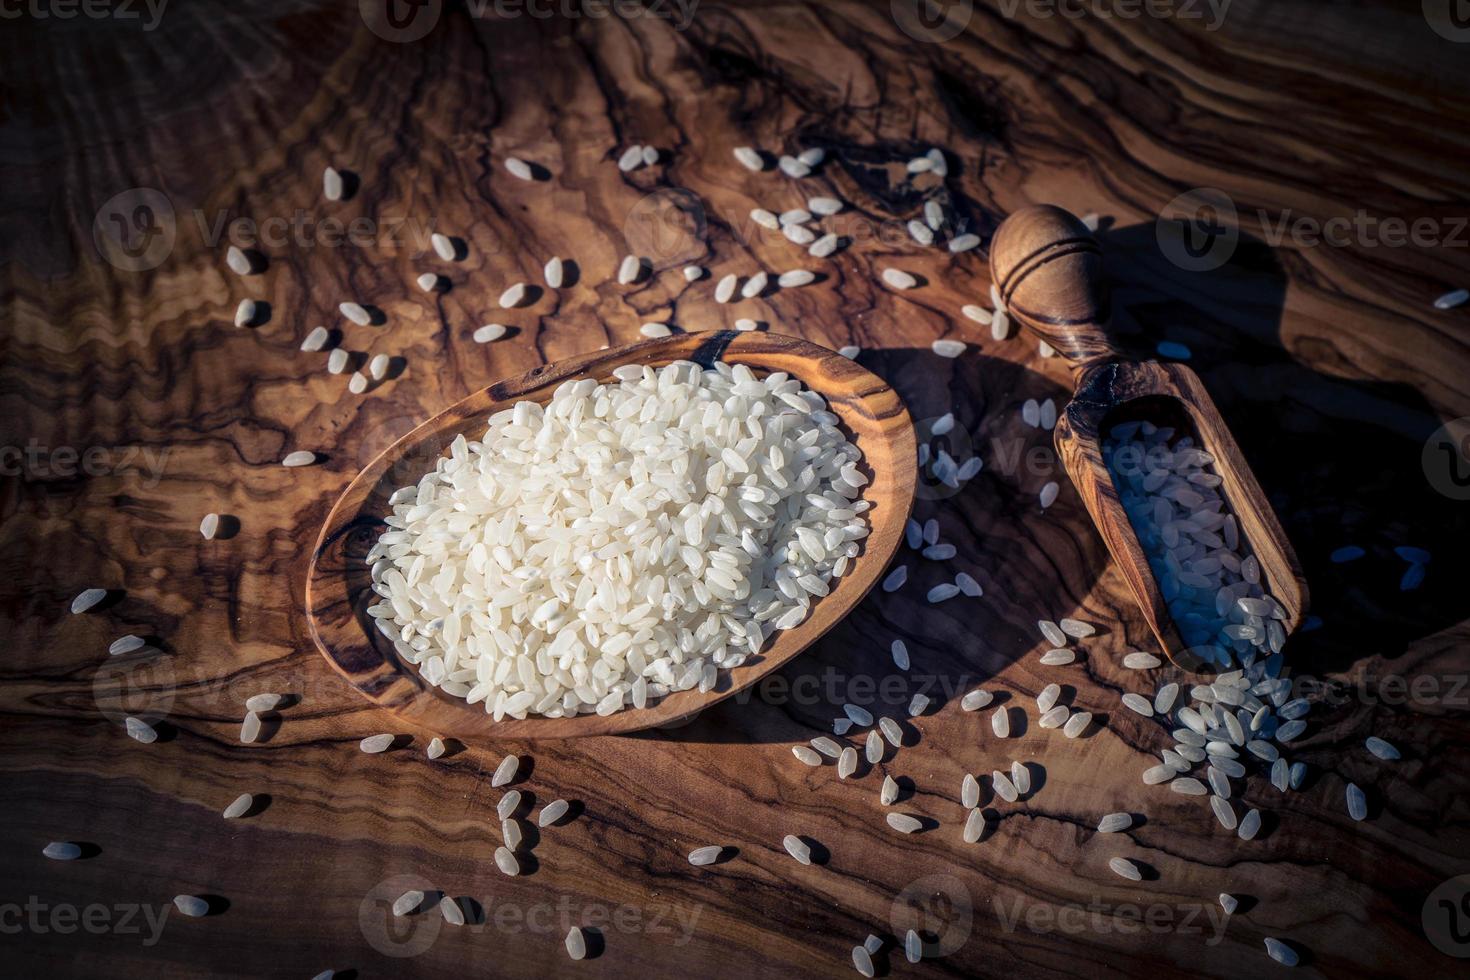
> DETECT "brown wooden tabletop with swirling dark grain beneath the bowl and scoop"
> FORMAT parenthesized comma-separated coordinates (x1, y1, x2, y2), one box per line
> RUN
(0, 0, 1470, 979)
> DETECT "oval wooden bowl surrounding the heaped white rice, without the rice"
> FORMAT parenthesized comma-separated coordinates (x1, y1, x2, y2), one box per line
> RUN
(306, 331, 917, 739)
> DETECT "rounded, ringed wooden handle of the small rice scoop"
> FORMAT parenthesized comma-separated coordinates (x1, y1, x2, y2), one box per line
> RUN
(991, 204, 1120, 373)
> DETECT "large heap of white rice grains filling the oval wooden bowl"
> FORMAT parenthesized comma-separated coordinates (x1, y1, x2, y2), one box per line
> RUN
(368, 361, 869, 720)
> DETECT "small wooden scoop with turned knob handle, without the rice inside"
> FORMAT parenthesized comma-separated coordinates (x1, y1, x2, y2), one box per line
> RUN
(991, 206, 1307, 670)
